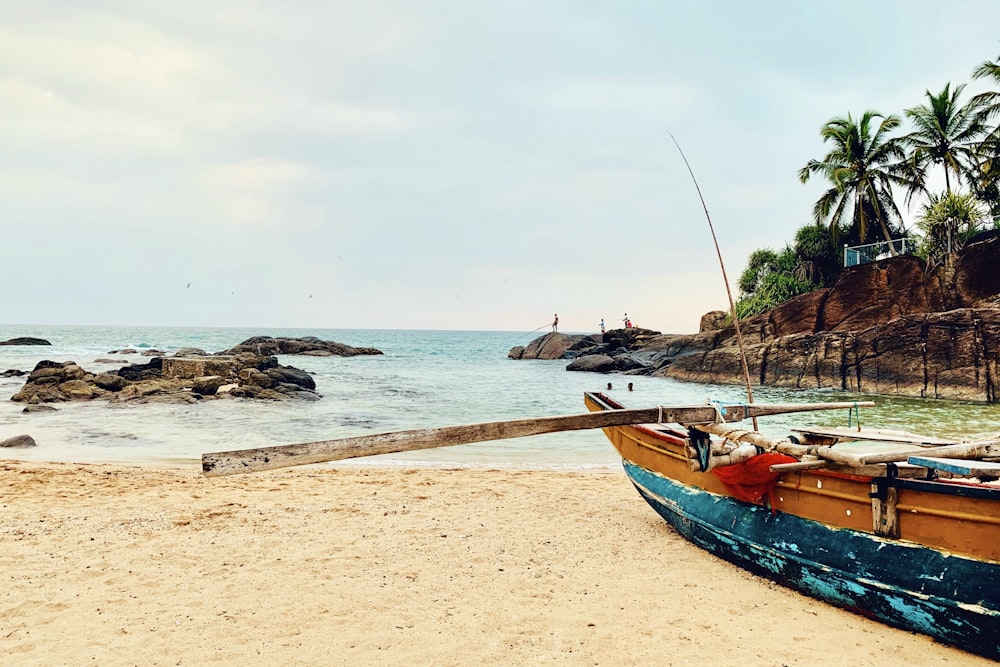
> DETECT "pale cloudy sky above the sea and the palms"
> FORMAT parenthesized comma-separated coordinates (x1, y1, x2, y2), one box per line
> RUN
(0, 0, 1000, 333)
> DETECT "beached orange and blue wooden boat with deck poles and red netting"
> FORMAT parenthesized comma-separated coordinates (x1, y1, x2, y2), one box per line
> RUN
(585, 393, 1000, 660)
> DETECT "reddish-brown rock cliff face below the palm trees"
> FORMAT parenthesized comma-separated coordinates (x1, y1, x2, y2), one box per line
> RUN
(644, 239, 1000, 402)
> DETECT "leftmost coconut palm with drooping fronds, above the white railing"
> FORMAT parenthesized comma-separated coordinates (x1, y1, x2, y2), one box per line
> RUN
(799, 111, 912, 248)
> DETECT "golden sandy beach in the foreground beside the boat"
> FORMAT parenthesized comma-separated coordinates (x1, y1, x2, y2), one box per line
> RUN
(0, 461, 988, 665)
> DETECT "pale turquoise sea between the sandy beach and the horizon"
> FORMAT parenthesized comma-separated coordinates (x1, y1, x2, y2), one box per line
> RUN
(0, 325, 1000, 470)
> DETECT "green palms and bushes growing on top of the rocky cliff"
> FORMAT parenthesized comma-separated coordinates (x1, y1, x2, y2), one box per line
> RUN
(736, 51, 1000, 319)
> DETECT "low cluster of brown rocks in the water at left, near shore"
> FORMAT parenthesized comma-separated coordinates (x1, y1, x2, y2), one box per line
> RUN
(11, 353, 319, 404)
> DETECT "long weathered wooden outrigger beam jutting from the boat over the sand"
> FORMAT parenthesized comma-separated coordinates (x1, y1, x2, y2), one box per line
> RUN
(201, 402, 873, 476)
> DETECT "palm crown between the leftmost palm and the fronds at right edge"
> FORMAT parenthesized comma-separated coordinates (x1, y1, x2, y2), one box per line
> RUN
(903, 83, 986, 192)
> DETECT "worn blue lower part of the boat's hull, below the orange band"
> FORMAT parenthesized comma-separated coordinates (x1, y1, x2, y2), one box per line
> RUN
(624, 460, 1000, 660)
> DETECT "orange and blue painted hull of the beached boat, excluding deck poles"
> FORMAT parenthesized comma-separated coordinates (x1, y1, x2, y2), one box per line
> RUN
(585, 394, 1000, 660)
